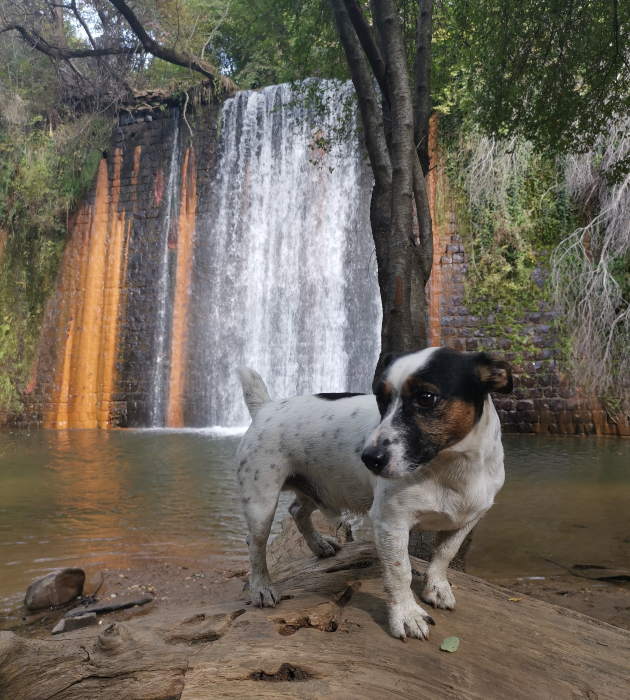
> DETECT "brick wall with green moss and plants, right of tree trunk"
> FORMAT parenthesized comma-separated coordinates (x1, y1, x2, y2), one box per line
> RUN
(429, 119, 630, 437)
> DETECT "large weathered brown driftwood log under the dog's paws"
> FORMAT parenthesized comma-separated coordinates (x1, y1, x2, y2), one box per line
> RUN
(0, 542, 630, 700)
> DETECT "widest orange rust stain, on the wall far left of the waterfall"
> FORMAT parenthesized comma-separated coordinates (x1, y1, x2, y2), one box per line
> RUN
(44, 149, 132, 428)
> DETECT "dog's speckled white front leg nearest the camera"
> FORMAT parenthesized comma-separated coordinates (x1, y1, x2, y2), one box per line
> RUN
(372, 518, 435, 641)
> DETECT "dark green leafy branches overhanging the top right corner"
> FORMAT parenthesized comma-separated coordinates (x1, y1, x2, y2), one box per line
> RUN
(437, 0, 630, 159)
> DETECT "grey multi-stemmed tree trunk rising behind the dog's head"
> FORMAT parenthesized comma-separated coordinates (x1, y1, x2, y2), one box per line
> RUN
(330, 0, 433, 381)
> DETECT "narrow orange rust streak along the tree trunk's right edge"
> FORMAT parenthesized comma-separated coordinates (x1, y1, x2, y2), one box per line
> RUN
(428, 113, 443, 347)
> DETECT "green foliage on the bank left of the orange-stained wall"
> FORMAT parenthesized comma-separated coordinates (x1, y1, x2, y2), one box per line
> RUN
(0, 108, 110, 412)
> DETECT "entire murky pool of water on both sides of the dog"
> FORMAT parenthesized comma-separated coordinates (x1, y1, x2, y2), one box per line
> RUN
(0, 430, 630, 610)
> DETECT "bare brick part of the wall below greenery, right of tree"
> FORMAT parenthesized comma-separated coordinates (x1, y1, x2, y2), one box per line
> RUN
(429, 214, 630, 437)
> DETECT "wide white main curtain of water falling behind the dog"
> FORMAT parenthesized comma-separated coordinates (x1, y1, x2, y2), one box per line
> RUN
(187, 84, 382, 426)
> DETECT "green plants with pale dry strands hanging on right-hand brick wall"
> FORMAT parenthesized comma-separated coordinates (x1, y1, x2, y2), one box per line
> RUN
(440, 115, 577, 362)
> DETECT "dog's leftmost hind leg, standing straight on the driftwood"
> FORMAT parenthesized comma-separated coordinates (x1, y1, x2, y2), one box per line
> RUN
(243, 489, 280, 608)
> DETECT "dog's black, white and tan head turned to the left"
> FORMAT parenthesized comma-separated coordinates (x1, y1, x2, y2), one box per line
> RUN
(361, 348, 512, 478)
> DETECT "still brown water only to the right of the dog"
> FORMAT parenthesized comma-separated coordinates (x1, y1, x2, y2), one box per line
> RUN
(468, 435, 630, 579)
